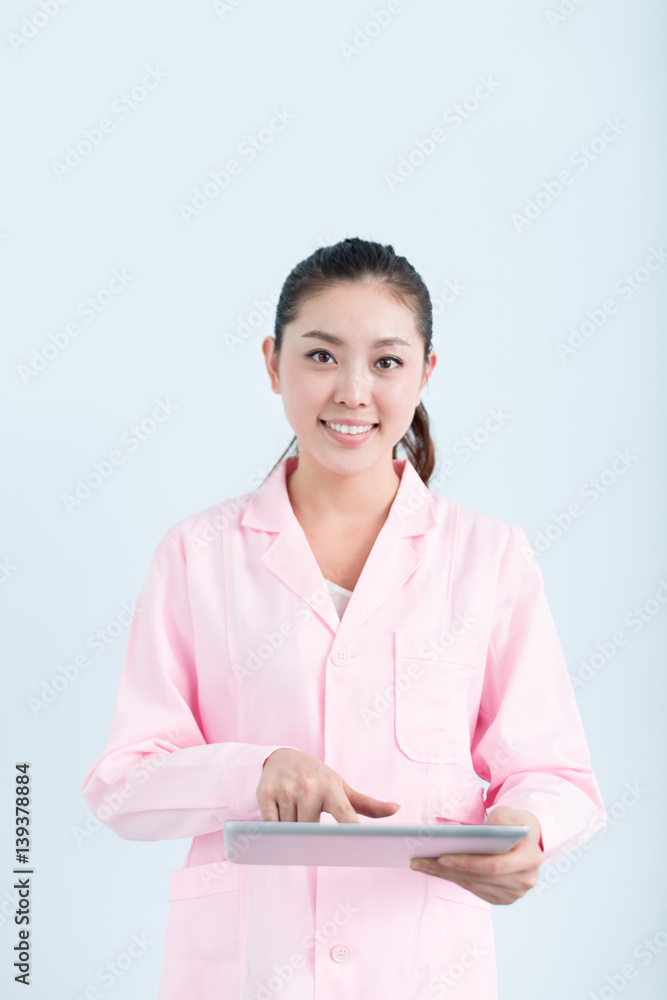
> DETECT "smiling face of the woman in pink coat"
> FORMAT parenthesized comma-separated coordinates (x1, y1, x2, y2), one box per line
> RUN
(262, 282, 436, 475)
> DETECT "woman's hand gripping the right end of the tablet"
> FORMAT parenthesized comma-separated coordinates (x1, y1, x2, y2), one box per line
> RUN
(410, 806, 544, 904)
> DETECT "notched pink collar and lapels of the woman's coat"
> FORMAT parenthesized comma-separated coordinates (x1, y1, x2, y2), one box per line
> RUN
(241, 456, 436, 641)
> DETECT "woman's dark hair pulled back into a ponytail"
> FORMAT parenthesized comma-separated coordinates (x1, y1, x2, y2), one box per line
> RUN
(269, 236, 435, 486)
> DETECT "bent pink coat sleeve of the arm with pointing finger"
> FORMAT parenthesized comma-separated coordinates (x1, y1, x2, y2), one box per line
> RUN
(81, 529, 298, 840)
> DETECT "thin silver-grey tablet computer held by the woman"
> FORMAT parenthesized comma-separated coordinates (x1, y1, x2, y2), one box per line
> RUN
(224, 820, 530, 868)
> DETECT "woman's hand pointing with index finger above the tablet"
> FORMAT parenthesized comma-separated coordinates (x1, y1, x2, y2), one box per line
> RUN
(255, 748, 401, 823)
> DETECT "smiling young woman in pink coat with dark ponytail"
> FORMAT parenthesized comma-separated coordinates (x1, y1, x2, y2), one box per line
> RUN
(82, 239, 606, 1000)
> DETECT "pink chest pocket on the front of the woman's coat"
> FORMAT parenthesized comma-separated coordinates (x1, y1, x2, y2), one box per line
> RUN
(394, 629, 482, 764)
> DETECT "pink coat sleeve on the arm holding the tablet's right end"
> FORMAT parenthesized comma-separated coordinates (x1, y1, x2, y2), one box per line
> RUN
(471, 525, 607, 862)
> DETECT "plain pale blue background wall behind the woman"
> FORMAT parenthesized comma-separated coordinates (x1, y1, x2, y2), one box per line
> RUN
(0, 0, 667, 1000)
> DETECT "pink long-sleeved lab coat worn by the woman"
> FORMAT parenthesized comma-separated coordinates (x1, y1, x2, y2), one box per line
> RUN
(82, 457, 606, 1000)
